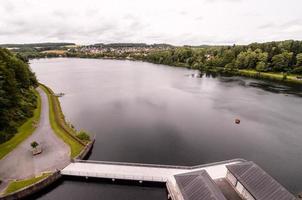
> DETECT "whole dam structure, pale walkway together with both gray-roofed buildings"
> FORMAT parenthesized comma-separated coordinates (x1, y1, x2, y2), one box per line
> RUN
(61, 159, 296, 200)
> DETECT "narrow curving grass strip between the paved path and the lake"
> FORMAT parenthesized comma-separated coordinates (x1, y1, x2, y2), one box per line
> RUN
(40, 85, 85, 158)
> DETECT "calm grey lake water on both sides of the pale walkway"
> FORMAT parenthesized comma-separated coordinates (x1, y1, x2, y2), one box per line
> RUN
(31, 58, 302, 200)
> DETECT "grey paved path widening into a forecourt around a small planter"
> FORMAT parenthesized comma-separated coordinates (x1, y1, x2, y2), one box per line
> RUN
(0, 88, 70, 191)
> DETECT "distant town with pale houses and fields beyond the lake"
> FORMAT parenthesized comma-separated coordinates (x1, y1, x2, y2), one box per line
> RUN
(0, 43, 175, 58)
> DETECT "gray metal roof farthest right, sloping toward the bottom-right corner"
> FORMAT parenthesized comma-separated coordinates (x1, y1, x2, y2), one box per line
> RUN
(226, 162, 296, 200)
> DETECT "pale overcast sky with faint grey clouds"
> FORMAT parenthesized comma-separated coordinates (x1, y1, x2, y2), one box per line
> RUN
(0, 0, 302, 45)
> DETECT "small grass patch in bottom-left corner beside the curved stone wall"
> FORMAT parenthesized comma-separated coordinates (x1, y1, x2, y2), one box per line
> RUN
(3, 173, 51, 195)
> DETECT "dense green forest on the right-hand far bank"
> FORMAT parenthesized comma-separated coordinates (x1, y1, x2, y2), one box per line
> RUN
(145, 40, 302, 74)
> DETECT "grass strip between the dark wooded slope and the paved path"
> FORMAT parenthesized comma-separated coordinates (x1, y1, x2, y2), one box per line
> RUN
(0, 91, 41, 159)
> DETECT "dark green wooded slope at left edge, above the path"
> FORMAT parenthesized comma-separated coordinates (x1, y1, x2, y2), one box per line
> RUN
(0, 48, 38, 143)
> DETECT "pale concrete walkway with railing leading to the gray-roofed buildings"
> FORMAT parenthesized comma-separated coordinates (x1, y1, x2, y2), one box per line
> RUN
(61, 159, 245, 200)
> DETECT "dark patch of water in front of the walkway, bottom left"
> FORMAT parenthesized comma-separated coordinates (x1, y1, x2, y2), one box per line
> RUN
(27, 177, 167, 200)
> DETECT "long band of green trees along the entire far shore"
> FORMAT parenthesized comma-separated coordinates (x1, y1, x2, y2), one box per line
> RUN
(7, 40, 302, 75)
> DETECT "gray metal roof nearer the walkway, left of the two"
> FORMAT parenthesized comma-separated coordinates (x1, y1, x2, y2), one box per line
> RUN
(174, 170, 226, 200)
